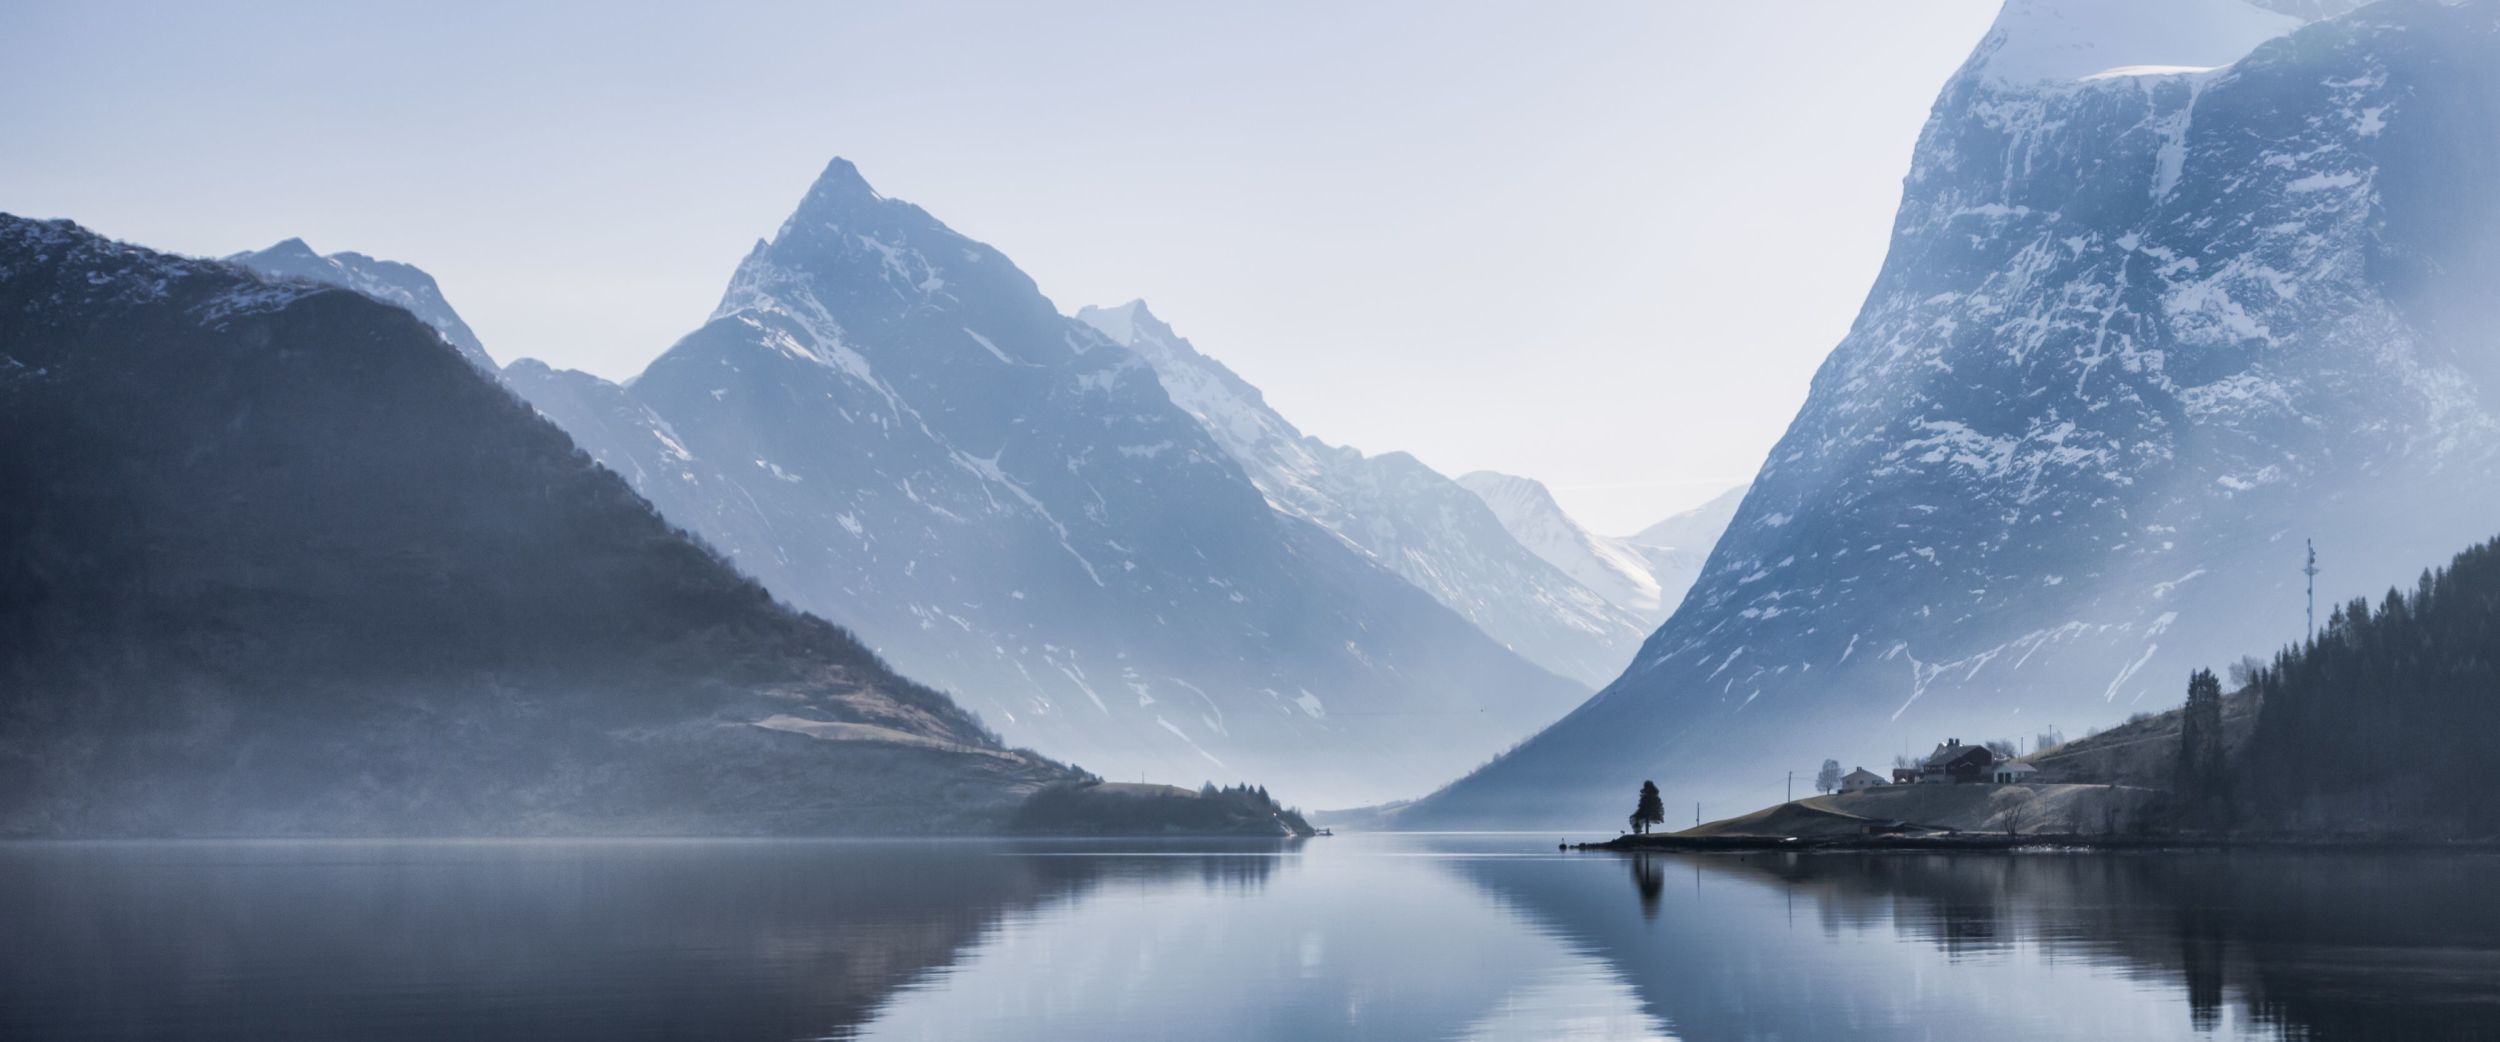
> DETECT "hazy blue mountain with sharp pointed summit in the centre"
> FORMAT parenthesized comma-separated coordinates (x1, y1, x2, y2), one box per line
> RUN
(505, 160, 1580, 802)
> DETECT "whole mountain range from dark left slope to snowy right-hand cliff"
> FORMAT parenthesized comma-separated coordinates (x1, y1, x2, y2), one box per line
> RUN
(39, 0, 2500, 835)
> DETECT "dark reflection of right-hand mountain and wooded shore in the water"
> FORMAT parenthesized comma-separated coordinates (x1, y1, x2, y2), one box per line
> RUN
(1463, 852, 2500, 1040)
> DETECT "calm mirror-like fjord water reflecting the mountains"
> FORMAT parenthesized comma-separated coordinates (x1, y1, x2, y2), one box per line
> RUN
(0, 835, 2500, 1040)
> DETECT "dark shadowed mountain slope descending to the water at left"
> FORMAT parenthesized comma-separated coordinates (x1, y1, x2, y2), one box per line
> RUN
(0, 215, 1080, 835)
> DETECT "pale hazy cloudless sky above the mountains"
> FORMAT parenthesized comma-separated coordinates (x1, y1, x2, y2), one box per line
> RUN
(0, 0, 1998, 532)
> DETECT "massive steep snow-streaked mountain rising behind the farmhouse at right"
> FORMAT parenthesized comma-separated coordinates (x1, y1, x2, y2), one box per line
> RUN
(1408, 0, 2500, 825)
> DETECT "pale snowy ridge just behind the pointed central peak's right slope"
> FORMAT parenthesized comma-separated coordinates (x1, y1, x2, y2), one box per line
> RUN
(1078, 300, 1658, 690)
